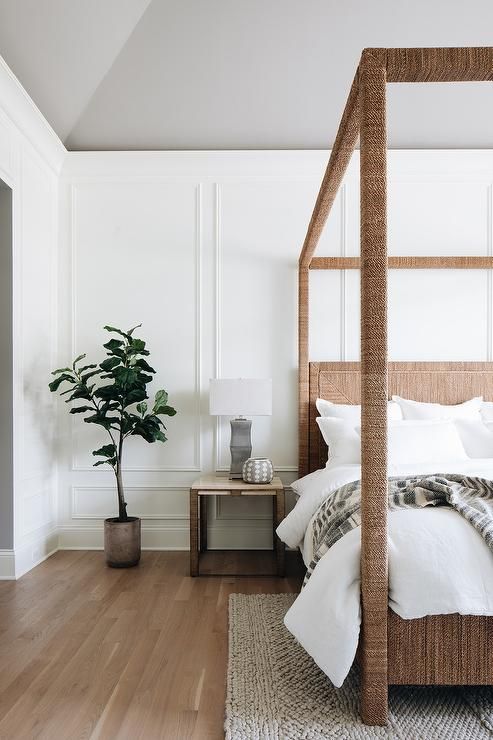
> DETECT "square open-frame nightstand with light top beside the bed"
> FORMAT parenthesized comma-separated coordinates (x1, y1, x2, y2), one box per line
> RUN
(190, 475, 284, 576)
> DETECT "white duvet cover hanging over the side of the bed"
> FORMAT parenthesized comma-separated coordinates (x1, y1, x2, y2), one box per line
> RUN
(277, 458, 493, 686)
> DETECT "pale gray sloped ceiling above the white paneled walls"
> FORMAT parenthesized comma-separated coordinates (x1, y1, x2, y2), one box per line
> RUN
(0, 0, 493, 150)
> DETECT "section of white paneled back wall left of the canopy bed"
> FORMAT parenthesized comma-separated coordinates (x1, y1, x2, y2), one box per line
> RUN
(59, 152, 324, 548)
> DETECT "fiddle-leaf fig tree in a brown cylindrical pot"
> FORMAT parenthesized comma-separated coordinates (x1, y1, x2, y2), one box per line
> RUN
(49, 324, 176, 568)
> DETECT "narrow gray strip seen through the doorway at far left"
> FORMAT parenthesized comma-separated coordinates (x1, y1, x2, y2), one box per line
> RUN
(0, 180, 14, 550)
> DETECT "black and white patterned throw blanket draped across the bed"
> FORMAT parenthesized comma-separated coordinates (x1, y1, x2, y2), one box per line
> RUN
(303, 473, 493, 585)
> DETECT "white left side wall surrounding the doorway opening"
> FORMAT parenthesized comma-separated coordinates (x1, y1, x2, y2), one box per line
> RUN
(0, 60, 64, 578)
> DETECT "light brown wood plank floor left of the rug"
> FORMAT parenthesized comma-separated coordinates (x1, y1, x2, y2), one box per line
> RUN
(0, 552, 300, 740)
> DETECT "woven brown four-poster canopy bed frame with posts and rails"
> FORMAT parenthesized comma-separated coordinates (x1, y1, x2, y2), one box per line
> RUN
(299, 48, 493, 724)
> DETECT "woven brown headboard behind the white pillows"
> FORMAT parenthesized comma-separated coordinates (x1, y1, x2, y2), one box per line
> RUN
(306, 362, 493, 475)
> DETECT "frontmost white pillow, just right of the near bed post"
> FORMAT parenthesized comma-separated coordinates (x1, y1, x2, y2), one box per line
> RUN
(356, 419, 467, 465)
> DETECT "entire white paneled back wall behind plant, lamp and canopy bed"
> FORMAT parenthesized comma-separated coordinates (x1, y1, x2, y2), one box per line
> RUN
(59, 151, 493, 548)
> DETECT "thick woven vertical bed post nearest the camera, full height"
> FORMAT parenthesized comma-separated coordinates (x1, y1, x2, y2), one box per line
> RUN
(360, 47, 388, 725)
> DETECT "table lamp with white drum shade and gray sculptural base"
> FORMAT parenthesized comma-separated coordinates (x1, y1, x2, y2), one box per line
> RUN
(209, 378, 272, 479)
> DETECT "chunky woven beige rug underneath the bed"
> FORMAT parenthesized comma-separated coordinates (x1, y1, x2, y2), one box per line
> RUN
(225, 594, 493, 740)
